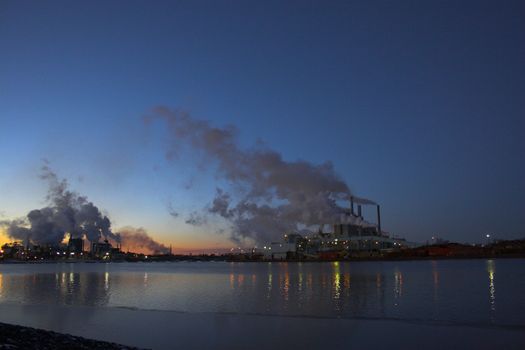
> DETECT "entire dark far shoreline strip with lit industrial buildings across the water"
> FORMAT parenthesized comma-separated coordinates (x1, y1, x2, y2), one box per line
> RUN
(0, 198, 525, 262)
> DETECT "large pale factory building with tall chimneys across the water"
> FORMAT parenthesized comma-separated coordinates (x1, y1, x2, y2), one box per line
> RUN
(254, 198, 414, 260)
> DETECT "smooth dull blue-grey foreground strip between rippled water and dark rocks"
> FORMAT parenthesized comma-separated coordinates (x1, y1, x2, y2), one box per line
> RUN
(0, 304, 525, 349)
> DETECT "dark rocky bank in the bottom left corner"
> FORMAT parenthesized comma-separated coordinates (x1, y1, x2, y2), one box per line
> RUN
(0, 323, 145, 350)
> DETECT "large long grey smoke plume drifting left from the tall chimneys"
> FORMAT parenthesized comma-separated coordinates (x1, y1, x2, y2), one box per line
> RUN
(145, 107, 373, 242)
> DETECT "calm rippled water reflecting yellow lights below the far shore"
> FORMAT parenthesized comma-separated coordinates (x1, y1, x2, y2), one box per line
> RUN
(0, 259, 525, 326)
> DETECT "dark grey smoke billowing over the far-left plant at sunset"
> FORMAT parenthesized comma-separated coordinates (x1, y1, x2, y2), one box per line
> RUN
(0, 162, 164, 252)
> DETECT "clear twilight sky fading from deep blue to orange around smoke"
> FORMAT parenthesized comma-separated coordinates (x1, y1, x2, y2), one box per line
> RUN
(0, 0, 525, 251)
